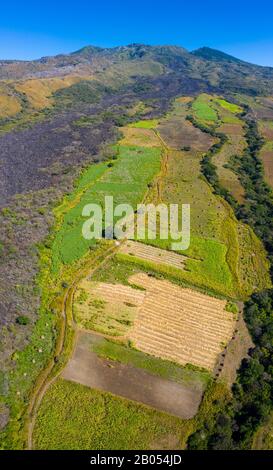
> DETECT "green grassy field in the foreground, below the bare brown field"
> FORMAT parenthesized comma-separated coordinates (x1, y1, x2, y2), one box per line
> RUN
(34, 379, 229, 450)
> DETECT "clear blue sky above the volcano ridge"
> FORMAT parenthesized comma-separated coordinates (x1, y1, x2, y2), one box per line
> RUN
(0, 0, 273, 66)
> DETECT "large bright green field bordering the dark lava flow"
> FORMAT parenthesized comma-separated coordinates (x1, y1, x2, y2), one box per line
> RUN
(53, 145, 161, 272)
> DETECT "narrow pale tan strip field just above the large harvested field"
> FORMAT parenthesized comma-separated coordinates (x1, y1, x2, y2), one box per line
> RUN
(119, 240, 187, 269)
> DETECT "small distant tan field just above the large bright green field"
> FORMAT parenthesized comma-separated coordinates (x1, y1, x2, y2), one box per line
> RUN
(120, 127, 159, 147)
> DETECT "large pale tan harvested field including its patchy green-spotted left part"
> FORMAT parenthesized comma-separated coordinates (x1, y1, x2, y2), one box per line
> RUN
(74, 273, 236, 370)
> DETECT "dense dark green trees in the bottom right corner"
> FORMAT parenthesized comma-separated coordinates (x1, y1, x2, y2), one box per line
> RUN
(189, 289, 273, 450)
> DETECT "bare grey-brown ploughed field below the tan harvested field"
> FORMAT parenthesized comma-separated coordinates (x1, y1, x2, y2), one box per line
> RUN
(62, 332, 203, 419)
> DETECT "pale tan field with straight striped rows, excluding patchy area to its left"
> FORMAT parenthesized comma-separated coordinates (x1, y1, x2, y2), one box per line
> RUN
(129, 273, 236, 370)
